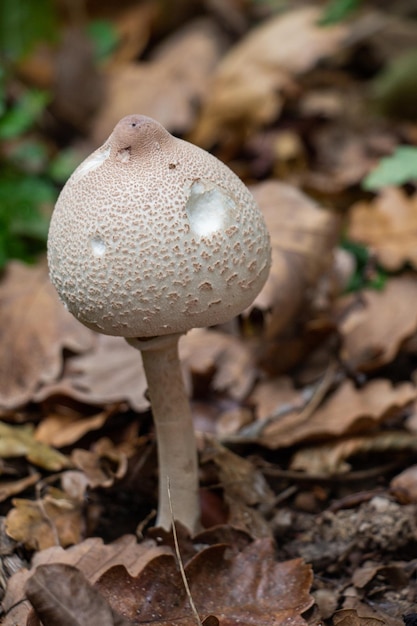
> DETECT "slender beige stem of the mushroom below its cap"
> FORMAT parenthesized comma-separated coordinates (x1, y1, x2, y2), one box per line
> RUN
(127, 334, 200, 534)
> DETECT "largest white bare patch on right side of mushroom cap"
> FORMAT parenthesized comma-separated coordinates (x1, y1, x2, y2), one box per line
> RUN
(185, 180, 236, 237)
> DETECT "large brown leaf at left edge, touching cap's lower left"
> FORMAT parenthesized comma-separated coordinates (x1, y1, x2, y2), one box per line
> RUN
(0, 262, 93, 409)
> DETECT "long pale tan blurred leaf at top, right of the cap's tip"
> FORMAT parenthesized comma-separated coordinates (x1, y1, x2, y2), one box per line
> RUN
(191, 7, 349, 147)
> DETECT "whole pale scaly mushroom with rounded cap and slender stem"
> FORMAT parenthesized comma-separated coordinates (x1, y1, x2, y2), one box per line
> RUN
(48, 115, 271, 532)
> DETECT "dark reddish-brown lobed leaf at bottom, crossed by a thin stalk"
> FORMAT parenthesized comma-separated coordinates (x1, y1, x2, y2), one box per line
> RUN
(96, 539, 313, 626)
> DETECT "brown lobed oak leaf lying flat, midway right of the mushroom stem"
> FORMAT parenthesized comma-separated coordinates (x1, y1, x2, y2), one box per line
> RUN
(258, 379, 417, 449)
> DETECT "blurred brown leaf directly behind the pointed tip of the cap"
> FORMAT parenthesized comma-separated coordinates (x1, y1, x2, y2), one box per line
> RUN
(93, 20, 223, 145)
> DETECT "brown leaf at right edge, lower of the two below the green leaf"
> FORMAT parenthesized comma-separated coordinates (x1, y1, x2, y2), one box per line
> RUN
(336, 274, 417, 371)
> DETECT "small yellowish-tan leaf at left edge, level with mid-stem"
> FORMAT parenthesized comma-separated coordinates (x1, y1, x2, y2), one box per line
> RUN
(0, 422, 70, 472)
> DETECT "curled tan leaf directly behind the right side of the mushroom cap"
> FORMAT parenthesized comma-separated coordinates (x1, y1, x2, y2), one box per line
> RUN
(251, 181, 340, 337)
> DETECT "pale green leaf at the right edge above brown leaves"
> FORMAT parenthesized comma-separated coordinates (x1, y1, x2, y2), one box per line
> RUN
(362, 146, 417, 191)
